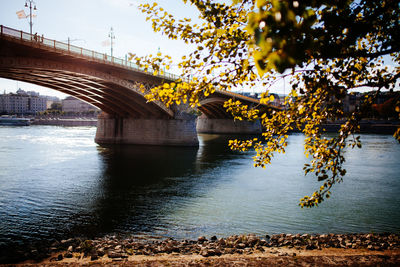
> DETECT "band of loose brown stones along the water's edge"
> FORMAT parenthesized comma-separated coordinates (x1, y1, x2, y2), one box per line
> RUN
(3, 234, 400, 261)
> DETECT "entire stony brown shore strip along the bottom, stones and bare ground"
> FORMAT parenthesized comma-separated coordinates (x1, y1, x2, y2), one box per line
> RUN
(2, 234, 400, 266)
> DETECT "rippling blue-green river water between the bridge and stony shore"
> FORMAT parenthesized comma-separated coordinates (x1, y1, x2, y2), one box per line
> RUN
(0, 126, 400, 250)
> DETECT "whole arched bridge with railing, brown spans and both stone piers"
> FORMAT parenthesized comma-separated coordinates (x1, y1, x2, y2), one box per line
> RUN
(0, 25, 272, 146)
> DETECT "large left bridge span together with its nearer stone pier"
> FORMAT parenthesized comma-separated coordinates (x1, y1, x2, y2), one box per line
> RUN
(0, 33, 203, 146)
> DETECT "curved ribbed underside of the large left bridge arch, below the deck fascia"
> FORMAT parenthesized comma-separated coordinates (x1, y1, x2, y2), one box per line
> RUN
(0, 57, 174, 118)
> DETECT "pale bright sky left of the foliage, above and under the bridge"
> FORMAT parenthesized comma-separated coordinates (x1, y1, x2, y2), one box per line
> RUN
(0, 0, 198, 98)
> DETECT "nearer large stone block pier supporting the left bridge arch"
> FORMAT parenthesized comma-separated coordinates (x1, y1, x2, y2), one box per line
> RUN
(95, 112, 199, 146)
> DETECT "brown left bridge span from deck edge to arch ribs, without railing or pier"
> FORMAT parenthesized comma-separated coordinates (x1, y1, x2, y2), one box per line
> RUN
(0, 36, 174, 119)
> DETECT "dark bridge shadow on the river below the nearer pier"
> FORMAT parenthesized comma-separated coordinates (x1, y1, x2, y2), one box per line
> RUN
(79, 135, 253, 239)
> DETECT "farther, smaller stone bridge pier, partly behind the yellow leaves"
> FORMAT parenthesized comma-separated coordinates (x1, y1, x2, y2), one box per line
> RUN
(197, 117, 262, 134)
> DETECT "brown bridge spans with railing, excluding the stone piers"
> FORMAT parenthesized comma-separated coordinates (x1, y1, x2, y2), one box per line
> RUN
(0, 25, 279, 118)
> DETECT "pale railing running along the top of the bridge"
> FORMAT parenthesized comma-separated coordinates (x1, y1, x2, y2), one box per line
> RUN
(0, 25, 181, 80)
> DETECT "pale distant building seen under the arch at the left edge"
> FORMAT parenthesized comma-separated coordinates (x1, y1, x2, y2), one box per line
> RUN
(0, 89, 47, 114)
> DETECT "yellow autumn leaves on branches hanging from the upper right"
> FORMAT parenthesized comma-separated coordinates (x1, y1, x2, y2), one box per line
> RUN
(131, 0, 400, 207)
